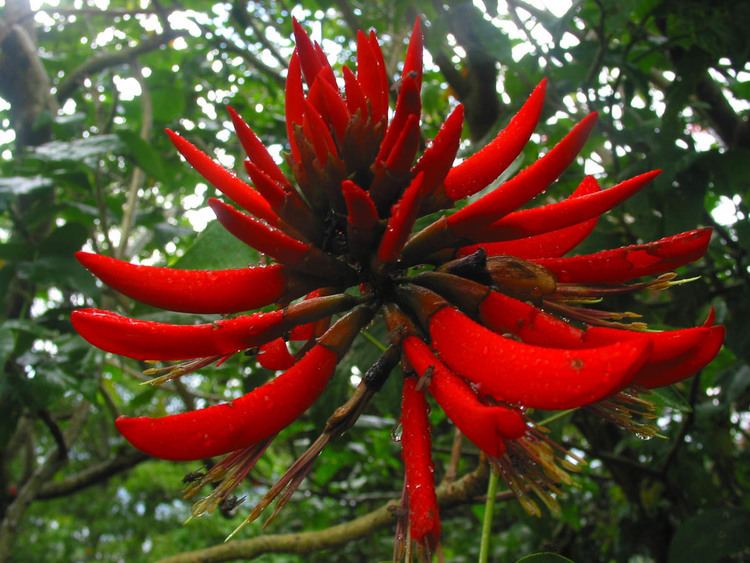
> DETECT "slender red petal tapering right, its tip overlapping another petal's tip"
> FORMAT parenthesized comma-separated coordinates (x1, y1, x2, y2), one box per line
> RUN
(481, 170, 661, 241)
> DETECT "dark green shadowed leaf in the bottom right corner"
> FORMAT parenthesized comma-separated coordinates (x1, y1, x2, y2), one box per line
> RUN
(668, 508, 750, 563)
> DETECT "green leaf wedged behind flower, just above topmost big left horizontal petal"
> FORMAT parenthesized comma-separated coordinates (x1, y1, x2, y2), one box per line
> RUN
(172, 221, 258, 270)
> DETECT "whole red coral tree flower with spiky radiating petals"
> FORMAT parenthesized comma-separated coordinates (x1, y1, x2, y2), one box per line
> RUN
(72, 16, 724, 552)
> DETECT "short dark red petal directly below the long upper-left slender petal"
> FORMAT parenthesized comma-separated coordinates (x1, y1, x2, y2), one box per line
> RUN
(208, 198, 311, 264)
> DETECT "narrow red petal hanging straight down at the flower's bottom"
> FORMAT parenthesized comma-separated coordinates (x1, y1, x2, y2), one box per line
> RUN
(401, 377, 440, 549)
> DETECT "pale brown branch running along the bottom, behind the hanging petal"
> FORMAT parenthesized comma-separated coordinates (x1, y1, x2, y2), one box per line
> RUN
(156, 463, 488, 563)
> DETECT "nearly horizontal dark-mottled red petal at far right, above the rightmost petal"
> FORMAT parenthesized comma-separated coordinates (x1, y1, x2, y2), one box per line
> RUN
(534, 228, 711, 284)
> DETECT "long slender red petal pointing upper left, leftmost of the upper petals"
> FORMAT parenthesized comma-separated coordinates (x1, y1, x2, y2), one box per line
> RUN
(166, 129, 280, 225)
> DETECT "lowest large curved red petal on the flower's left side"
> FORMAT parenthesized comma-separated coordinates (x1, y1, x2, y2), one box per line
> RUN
(115, 346, 337, 461)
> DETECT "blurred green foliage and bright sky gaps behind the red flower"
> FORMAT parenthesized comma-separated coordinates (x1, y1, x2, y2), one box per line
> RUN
(0, 0, 750, 562)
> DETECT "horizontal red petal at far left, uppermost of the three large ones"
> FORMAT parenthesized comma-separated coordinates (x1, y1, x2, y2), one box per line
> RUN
(76, 252, 296, 313)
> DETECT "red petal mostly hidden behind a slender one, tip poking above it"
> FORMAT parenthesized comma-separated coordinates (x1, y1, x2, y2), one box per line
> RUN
(456, 176, 601, 259)
